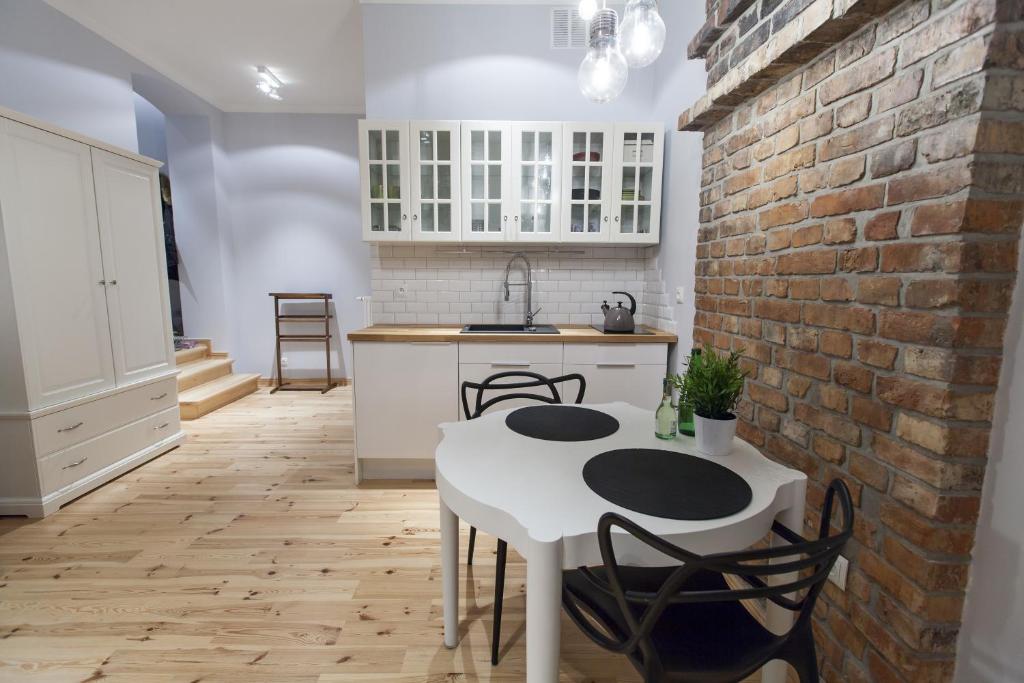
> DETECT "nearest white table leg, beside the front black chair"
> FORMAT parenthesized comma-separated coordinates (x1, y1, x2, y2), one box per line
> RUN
(526, 538, 562, 683)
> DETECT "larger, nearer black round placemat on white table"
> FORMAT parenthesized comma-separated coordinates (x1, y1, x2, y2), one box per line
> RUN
(583, 449, 754, 520)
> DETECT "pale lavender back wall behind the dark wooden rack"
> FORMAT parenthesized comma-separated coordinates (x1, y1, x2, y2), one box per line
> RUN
(223, 114, 370, 377)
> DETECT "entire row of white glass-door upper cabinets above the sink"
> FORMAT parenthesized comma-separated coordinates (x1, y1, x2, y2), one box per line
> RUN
(359, 121, 665, 245)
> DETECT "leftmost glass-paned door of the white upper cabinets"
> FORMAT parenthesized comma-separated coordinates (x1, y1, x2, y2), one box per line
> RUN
(359, 120, 413, 242)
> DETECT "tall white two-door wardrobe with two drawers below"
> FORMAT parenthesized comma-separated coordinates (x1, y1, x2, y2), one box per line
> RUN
(0, 109, 184, 517)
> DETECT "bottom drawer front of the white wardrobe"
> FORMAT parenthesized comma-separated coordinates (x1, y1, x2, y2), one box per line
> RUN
(39, 405, 179, 496)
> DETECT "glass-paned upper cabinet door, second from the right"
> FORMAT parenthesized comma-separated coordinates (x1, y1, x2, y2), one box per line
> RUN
(562, 123, 614, 242)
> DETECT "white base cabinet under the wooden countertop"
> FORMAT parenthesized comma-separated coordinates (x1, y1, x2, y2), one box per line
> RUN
(352, 342, 669, 480)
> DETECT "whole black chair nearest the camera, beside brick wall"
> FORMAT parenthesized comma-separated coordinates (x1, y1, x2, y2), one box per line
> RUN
(562, 479, 853, 683)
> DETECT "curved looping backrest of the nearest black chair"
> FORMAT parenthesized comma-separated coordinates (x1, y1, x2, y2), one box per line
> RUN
(567, 479, 853, 661)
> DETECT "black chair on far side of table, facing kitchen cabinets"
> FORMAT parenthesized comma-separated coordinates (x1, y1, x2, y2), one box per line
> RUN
(462, 371, 587, 666)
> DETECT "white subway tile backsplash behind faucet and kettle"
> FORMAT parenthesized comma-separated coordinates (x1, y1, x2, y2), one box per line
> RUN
(370, 245, 676, 331)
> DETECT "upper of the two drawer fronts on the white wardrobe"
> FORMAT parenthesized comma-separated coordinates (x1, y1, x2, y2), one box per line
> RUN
(32, 377, 178, 458)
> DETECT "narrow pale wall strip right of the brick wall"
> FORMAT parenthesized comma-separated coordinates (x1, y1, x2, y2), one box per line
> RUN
(955, 222, 1024, 683)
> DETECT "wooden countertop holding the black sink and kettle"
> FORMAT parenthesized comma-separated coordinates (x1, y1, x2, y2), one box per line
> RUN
(348, 325, 679, 344)
